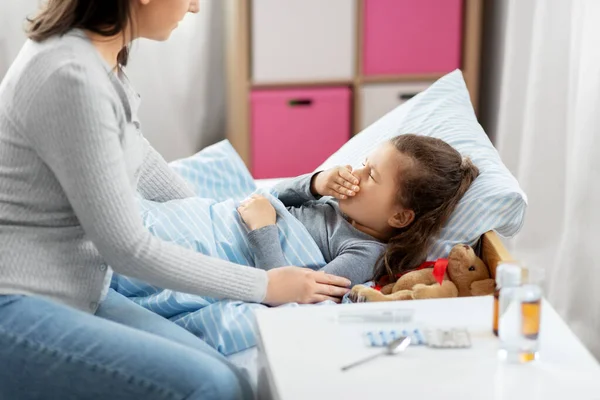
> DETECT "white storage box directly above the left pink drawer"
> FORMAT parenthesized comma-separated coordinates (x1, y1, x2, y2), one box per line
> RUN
(251, 0, 356, 84)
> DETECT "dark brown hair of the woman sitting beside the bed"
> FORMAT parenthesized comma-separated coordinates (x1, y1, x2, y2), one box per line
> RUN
(27, 0, 133, 66)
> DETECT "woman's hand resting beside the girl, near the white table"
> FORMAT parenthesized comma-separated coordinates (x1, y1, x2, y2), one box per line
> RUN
(263, 267, 350, 306)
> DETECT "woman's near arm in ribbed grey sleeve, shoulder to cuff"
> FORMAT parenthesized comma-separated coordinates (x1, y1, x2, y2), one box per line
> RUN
(23, 61, 267, 302)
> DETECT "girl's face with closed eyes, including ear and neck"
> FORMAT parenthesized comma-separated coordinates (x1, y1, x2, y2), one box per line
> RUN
(339, 143, 414, 238)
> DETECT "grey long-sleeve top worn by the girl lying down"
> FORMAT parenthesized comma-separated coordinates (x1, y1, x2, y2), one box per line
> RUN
(249, 174, 386, 285)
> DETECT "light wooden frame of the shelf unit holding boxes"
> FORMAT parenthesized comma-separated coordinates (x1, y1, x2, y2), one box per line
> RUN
(224, 0, 483, 170)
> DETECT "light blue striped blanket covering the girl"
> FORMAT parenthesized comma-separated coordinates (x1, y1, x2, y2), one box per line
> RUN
(112, 141, 325, 355)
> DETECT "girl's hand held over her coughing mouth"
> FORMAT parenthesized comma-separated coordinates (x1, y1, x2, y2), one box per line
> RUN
(310, 165, 360, 200)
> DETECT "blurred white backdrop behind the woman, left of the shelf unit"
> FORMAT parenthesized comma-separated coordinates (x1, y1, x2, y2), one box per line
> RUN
(0, 0, 225, 160)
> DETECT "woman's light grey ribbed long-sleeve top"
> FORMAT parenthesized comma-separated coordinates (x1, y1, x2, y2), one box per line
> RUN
(0, 30, 267, 312)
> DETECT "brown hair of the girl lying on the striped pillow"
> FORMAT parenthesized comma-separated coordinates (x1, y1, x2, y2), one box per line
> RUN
(375, 134, 479, 280)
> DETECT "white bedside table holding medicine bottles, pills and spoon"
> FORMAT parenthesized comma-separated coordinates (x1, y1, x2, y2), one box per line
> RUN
(257, 296, 600, 400)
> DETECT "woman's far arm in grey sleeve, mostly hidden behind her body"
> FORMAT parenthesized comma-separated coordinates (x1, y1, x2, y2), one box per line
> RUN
(137, 139, 196, 203)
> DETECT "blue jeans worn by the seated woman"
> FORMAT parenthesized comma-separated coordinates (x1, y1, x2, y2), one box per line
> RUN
(0, 289, 253, 400)
